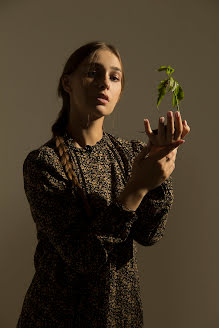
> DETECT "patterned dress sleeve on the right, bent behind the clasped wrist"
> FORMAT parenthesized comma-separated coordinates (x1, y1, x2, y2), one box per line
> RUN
(128, 140, 174, 246)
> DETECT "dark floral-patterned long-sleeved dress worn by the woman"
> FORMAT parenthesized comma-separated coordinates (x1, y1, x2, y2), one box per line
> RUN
(16, 131, 173, 328)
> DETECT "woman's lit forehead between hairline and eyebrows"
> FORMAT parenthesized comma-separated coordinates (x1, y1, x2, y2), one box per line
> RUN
(84, 49, 122, 71)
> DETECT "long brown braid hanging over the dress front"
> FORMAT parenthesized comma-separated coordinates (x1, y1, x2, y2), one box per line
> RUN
(55, 135, 92, 216)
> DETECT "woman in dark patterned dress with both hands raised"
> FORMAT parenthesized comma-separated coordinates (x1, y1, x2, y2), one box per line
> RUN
(17, 42, 190, 328)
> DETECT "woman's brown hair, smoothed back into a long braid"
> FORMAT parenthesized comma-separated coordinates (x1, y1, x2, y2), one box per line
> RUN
(52, 41, 125, 216)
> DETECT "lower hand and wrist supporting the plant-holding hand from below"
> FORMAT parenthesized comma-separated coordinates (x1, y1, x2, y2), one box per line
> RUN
(130, 140, 184, 195)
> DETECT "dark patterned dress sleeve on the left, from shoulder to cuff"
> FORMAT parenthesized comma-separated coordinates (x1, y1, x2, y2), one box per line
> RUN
(23, 147, 137, 275)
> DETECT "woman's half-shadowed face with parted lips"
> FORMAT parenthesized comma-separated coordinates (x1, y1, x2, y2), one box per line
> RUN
(62, 50, 122, 118)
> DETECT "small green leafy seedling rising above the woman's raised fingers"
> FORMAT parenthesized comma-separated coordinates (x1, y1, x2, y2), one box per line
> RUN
(157, 66, 184, 111)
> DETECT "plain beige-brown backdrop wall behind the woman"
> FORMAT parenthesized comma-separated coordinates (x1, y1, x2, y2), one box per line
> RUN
(0, 0, 219, 328)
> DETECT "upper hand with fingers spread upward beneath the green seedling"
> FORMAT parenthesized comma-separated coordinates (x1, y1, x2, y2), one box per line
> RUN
(144, 111, 190, 146)
